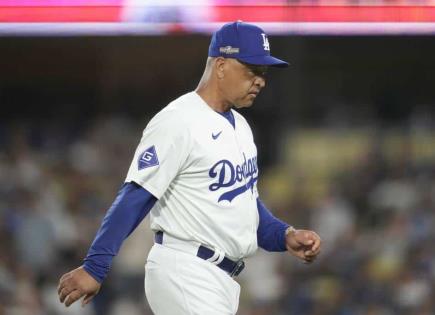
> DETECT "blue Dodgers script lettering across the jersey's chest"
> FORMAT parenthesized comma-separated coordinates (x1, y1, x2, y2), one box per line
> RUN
(208, 154, 258, 202)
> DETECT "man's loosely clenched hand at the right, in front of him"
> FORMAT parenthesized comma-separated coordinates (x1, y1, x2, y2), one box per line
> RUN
(286, 229, 322, 263)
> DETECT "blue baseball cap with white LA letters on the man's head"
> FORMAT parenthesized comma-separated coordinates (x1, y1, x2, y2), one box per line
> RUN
(208, 21, 288, 68)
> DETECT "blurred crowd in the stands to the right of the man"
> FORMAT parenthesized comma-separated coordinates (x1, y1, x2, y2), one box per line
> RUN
(241, 128, 435, 315)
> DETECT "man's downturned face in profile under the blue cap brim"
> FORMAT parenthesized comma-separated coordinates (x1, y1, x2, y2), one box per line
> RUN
(220, 58, 267, 108)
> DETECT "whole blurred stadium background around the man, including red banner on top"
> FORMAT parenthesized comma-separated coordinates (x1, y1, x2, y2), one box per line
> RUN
(0, 0, 435, 315)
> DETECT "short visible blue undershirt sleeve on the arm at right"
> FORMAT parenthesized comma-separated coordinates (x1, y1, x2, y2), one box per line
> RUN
(257, 198, 289, 252)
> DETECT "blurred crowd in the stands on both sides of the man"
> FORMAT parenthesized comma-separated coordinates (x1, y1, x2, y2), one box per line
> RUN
(0, 117, 435, 315)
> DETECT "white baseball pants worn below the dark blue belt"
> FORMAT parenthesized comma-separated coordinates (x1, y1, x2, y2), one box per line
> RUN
(145, 242, 240, 315)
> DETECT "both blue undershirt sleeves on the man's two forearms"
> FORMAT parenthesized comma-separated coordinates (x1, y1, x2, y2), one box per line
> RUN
(83, 182, 289, 283)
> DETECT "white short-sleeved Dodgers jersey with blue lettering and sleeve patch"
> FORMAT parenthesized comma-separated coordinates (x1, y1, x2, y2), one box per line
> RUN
(126, 92, 259, 260)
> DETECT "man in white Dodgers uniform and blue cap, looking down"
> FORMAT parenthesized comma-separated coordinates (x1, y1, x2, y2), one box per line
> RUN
(58, 22, 320, 315)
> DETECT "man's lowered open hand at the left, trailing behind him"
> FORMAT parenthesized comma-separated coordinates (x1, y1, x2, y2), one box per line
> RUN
(57, 266, 101, 307)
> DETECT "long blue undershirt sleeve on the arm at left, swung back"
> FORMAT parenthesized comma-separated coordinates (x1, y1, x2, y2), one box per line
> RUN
(83, 182, 157, 283)
